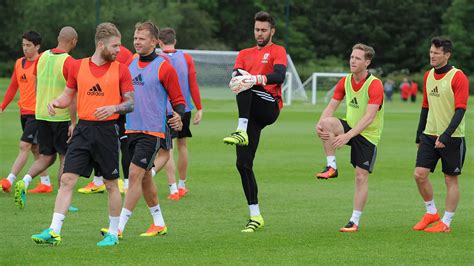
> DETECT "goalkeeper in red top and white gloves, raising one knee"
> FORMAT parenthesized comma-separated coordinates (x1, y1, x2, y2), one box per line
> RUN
(224, 11, 287, 232)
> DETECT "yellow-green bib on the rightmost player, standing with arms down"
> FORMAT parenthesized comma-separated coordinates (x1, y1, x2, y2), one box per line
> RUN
(423, 67, 465, 137)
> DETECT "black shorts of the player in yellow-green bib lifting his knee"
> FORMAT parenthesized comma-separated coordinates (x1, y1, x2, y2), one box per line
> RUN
(339, 119, 377, 173)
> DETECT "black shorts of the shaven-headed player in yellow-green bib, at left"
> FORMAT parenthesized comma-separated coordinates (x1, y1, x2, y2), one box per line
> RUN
(37, 120, 70, 155)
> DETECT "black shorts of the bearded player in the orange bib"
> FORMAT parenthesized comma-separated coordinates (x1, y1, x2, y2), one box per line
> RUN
(64, 120, 120, 180)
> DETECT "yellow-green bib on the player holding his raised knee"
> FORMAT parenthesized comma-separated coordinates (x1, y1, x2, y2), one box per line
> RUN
(344, 74, 385, 145)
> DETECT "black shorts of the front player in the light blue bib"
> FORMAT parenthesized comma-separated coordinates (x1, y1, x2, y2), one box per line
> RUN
(128, 131, 171, 171)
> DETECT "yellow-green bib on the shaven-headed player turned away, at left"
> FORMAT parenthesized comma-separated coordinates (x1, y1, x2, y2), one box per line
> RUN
(36, 50, 71, 122)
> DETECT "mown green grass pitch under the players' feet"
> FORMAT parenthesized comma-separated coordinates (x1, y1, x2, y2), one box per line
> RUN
(0, 77, 474, 265)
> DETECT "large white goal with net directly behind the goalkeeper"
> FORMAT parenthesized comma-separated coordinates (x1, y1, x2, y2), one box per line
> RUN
(182, 50, 308, 105)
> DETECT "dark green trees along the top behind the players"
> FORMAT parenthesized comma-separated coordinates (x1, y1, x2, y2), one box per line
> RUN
(0, 0, 474, 84)
